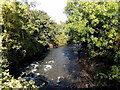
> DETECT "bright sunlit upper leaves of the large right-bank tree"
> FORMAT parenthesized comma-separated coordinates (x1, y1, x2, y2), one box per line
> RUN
(66, 2, 118, 54)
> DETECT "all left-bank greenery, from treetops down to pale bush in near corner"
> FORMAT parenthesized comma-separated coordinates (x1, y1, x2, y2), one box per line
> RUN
(0, 0, 67, 89)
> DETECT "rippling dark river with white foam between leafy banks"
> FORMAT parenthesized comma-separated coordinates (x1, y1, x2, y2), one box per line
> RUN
(20, 46, 94, 88)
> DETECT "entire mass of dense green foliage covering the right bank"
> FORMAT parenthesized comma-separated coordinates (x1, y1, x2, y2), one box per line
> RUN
(65, 2, 120, 85)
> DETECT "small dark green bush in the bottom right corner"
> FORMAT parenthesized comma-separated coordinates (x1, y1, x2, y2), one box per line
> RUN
(97, 65, 120, 86)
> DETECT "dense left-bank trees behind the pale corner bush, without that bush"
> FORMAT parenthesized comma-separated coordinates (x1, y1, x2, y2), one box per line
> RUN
(2, 2, 65, 67)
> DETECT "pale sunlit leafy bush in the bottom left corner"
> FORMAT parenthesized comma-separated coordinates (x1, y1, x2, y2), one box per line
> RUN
(0, 59, 38, 89)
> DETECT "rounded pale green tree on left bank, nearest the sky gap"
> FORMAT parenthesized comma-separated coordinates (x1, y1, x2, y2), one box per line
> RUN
(24, 10, 66, 47)
